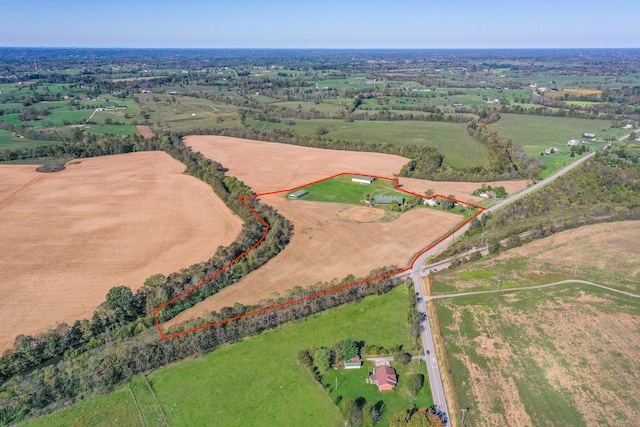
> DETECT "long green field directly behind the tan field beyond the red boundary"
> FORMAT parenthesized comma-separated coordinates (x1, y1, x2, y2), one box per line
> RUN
(247, 119, 488, 167)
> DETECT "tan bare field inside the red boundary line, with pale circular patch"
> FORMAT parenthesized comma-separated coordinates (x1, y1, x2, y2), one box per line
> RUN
(169, 192, 462, 328)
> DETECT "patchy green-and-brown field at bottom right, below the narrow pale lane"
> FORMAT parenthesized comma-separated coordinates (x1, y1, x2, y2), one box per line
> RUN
(436, 283, 640, 426)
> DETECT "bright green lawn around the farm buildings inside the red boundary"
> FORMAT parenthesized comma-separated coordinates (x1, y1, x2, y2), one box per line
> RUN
(292, 175, 408, 206)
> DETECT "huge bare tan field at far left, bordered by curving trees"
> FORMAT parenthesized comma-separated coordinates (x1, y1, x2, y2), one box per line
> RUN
(0, 152, 242, 350)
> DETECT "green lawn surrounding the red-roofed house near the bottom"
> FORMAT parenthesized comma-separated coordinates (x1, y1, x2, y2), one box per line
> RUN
(322, 360, 433, 426)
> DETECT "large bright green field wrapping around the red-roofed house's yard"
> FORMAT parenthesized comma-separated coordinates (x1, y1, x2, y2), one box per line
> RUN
(149, 287, 418, 426)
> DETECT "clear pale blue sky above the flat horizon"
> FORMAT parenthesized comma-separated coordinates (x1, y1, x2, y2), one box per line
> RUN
(0, 0, 640, 49)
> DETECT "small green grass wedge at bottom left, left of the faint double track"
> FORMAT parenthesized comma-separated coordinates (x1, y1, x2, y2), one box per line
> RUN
(20, 388, 142, 427)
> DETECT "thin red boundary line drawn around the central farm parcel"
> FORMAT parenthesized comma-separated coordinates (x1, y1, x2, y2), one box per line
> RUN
(151, 172, 485, 341)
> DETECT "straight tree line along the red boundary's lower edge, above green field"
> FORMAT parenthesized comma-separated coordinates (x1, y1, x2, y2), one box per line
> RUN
(0, 267, 399, 424)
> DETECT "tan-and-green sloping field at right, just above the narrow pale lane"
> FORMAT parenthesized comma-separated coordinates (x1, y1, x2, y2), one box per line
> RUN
(433, 221, 640, 294)
